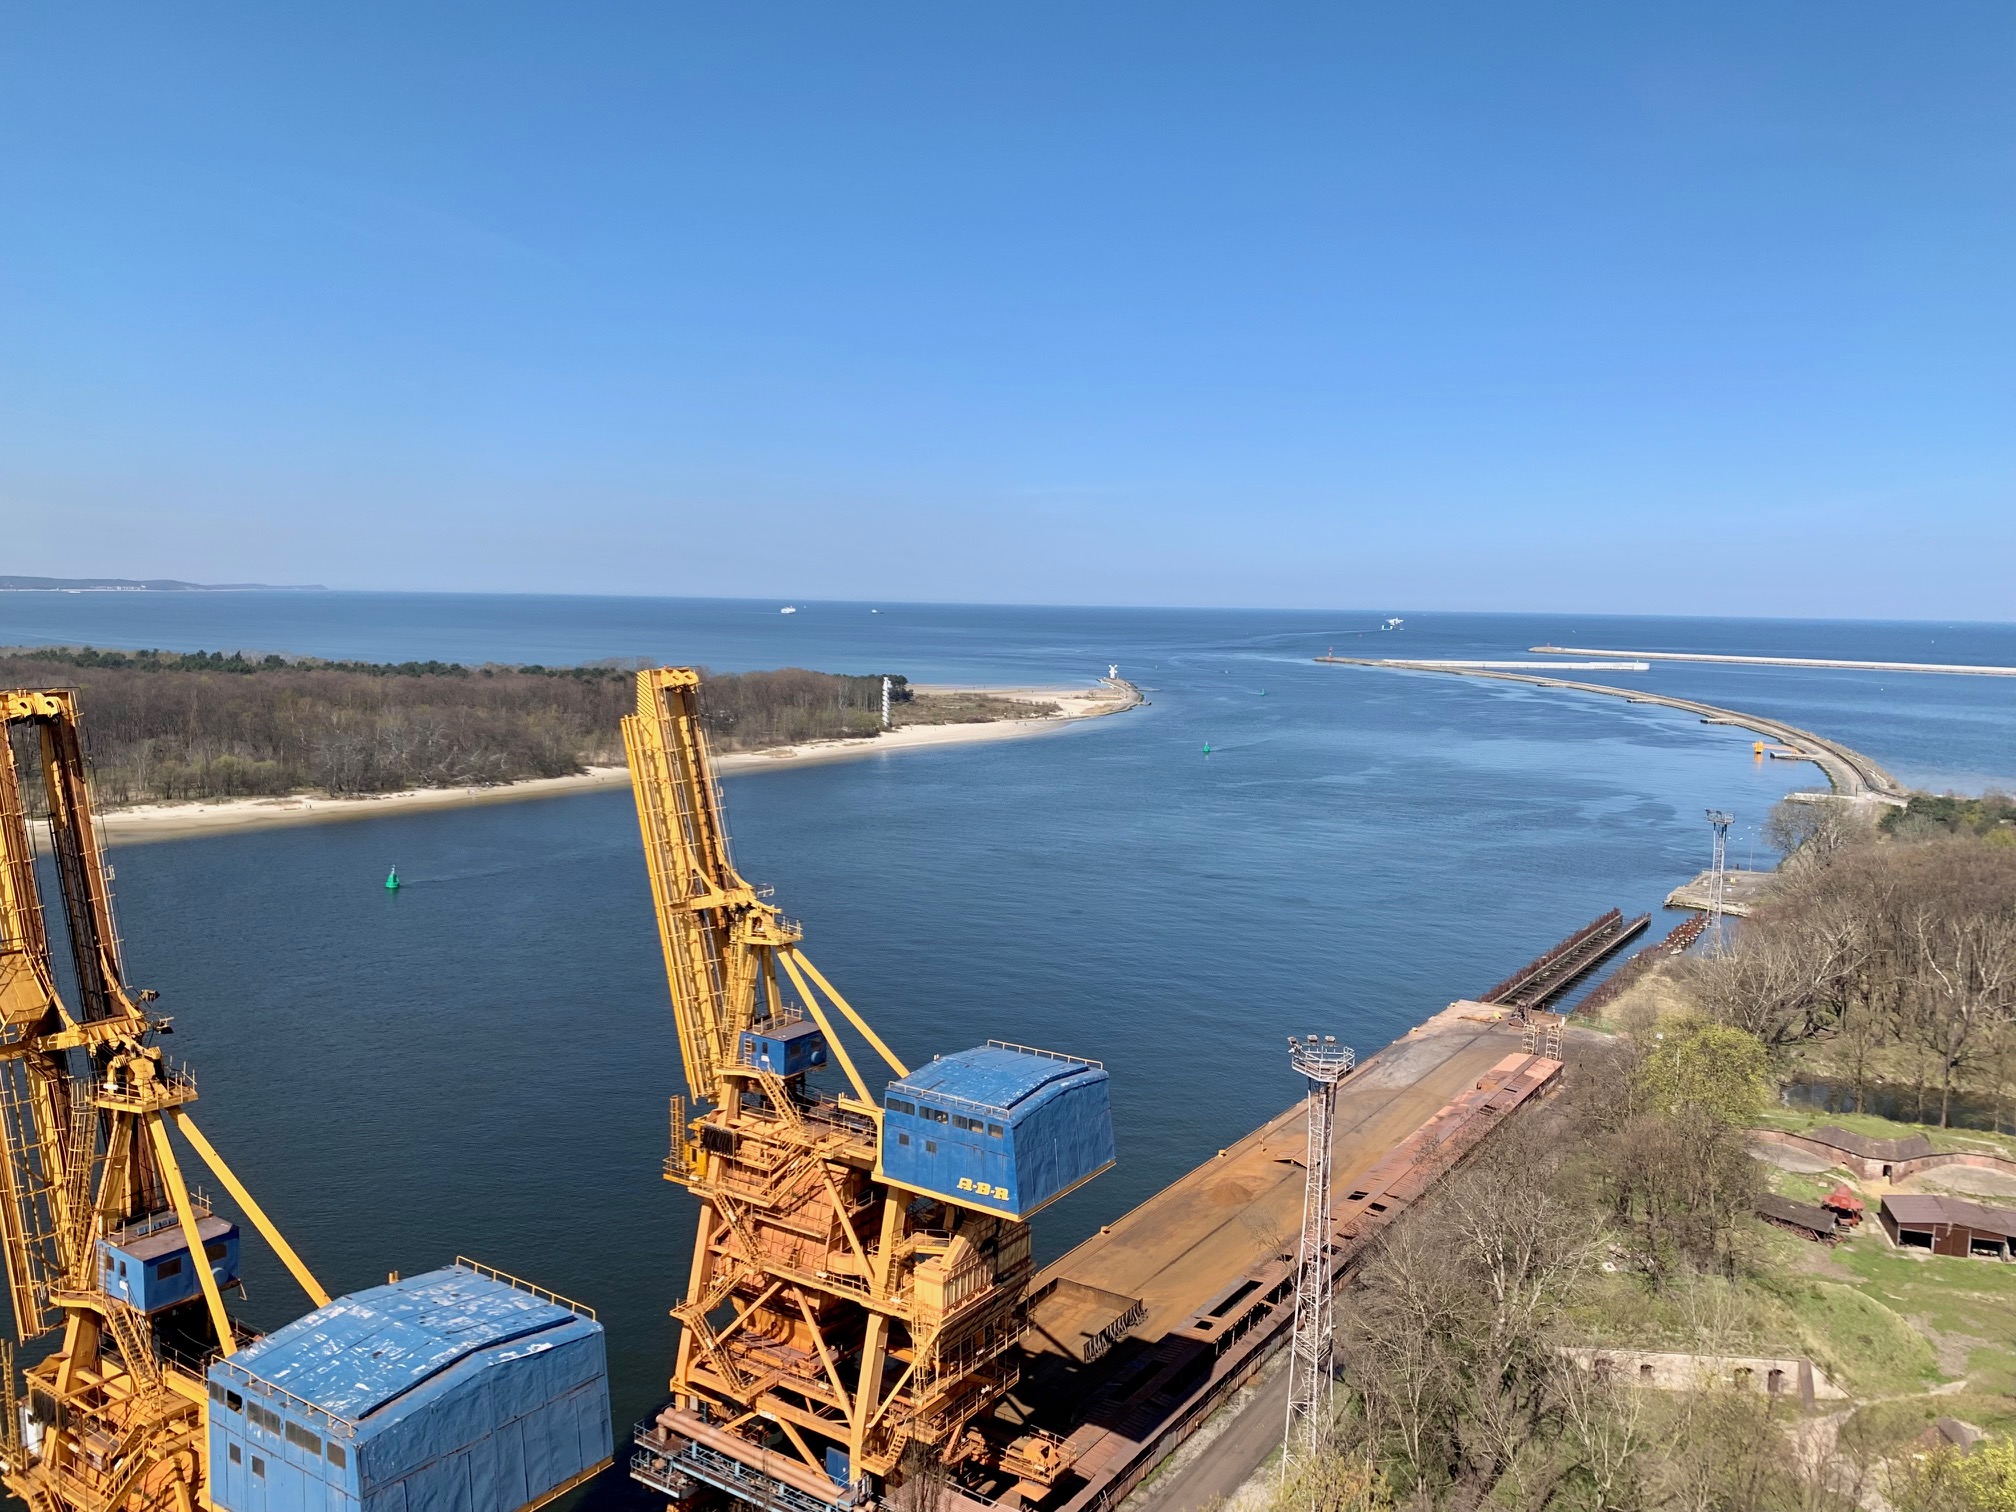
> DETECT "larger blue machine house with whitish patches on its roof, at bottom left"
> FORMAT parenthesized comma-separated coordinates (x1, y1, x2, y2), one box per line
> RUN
(210, 1266, 611, 1512)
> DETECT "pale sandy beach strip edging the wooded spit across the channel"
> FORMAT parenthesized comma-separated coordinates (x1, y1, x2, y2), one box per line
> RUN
(99, 681, 1141, 845)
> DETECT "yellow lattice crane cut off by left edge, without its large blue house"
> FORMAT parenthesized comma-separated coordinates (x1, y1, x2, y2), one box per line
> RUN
(0, 689, 329, 1512)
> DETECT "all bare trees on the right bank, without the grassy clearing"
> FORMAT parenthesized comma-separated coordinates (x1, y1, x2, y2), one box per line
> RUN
(1274, 796, 2016, 1512)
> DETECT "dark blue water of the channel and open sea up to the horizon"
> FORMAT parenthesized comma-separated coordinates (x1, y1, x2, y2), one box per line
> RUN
(0, 593, 2016, 1506)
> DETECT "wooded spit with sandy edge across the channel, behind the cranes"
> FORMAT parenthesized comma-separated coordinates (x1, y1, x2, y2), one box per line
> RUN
(0, 647, 1141, 843)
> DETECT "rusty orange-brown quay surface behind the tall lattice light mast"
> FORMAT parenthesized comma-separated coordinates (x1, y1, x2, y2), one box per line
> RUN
(1000, 1002, 1560, 1512)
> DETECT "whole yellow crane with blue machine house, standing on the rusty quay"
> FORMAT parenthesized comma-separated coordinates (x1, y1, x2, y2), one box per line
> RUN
(623, 667, 1113, 1512)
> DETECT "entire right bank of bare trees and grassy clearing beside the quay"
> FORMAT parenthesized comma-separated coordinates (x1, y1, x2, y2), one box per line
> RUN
(1228, 794, 2016, 1512)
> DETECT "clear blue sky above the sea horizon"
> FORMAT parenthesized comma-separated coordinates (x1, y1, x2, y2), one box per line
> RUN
(0, 0, 2016, 619)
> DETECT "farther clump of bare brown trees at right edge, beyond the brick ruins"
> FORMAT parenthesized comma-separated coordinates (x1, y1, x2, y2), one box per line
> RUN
(1681, 798, 2016, 1127)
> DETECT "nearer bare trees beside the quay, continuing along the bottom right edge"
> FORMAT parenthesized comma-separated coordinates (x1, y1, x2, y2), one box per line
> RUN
(1272, 1020, 2016, 1512)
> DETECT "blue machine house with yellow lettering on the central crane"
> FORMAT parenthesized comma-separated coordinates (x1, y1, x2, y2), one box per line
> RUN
(875, 1040, 1113, 1218)
